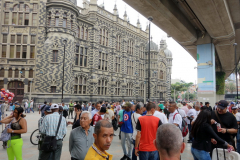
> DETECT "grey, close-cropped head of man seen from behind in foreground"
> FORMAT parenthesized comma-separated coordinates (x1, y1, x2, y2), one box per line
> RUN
(155, 123, 185, 160)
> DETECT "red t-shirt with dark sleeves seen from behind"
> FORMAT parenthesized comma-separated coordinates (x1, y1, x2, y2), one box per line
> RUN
(136, 115, 162, 152)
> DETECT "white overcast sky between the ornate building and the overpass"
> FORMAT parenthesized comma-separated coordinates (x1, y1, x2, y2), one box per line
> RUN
(78, 0, 197, 84)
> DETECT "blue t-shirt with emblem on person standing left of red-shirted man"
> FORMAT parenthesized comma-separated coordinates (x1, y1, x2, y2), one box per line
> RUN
(121, 111, 133, 133)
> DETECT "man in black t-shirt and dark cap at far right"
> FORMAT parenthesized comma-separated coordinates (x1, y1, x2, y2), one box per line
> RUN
(211, 100, 238, 150)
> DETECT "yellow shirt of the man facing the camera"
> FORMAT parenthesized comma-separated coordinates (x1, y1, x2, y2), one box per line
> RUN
(84, 143, 113, 160)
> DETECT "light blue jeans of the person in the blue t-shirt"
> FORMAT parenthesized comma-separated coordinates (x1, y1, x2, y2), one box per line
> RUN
(121, 131, 132, 158)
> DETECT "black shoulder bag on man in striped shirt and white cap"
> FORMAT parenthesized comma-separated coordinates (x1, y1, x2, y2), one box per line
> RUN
(41, 114, 62, 152)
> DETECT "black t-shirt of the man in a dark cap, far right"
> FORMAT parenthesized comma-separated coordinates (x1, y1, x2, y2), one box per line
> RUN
(212, 111, 238, 145)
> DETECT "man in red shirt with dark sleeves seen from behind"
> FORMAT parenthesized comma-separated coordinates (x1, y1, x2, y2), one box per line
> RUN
(135, 102, 162, 160)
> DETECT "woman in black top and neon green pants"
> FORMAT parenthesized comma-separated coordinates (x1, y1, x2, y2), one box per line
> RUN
(0, 107, 27, 160)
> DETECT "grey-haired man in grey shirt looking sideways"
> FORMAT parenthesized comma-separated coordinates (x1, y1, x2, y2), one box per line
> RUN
(69, 111, 94, 160)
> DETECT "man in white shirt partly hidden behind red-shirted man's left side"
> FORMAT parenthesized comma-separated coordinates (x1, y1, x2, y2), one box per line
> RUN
(131, 104, 143, 160)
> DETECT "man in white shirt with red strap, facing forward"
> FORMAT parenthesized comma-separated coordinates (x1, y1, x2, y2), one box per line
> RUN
(168, 102, 182, 129)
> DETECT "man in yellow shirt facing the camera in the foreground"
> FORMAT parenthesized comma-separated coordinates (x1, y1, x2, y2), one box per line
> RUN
(84, 120, 114, 160)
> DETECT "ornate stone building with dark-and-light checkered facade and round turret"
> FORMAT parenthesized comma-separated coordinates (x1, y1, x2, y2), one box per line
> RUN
(0, 0, 172, 103)
